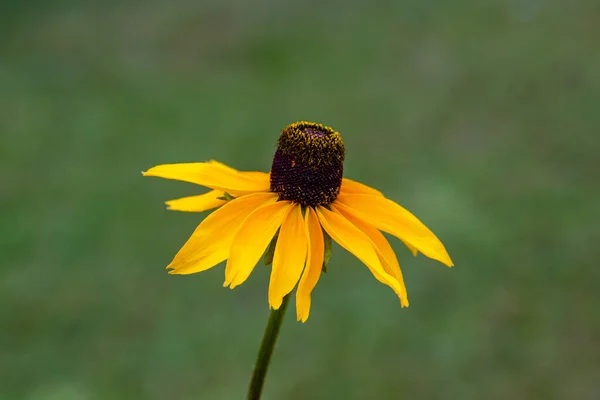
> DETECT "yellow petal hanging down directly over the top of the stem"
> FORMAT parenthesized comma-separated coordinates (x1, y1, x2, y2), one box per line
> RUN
(269, 203, 308, 310)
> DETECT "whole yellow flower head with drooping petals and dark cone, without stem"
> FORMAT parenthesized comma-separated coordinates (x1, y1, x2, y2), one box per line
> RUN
(143, 122, 453, 322)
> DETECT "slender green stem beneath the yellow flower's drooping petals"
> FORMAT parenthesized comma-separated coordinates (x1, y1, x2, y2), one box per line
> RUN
(248, 294, 290, 400)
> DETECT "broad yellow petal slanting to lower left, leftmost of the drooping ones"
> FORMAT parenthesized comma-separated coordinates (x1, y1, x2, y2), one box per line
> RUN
(167, 193, 278, 274)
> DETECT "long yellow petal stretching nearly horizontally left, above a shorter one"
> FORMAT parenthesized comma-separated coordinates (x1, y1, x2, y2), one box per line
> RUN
(142, 161, 271, 193)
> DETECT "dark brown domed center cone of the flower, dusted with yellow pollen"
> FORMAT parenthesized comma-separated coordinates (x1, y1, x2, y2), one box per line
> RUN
(271, 121, 345, 207)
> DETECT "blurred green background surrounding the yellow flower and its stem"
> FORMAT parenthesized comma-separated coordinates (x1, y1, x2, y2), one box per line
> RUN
(0, 0, 600, 400)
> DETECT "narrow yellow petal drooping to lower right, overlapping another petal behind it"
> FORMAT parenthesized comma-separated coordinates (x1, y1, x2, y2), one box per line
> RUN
(317, 206, 402, 297)
